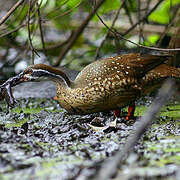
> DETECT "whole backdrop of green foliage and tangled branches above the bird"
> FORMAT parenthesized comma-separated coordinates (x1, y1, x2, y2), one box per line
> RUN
(0, 0, 180, 79)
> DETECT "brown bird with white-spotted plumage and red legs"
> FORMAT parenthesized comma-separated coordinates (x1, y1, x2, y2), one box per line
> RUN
(15, 53, 180, 120)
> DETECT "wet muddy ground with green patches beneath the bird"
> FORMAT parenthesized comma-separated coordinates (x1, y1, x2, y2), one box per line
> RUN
(0, 82, 180, 180)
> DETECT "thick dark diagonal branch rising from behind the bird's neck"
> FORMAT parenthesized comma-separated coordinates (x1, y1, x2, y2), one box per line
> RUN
(54, 0, 105, 66)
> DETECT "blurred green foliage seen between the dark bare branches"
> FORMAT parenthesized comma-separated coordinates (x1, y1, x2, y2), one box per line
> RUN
(0, 0, 180, 75)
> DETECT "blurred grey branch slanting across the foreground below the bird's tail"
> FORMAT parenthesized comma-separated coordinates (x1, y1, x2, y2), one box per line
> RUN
(95, 80, 175, 180)
